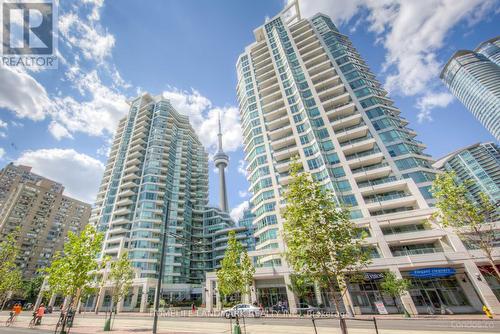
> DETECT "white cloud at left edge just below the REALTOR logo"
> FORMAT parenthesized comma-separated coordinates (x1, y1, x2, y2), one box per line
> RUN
(0, 64, 50, 120)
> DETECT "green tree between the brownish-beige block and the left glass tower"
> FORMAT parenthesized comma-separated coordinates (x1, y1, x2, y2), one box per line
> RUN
(45, 225, 103, 309)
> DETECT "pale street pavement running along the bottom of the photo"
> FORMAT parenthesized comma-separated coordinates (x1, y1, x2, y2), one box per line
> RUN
(0, 312, 500, 334)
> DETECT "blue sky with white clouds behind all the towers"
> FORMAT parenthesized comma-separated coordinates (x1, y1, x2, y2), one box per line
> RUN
(0, 0, 500, 222)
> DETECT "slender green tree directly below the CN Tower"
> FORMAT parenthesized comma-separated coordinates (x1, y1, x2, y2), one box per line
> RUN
(217, 231, 255, 297)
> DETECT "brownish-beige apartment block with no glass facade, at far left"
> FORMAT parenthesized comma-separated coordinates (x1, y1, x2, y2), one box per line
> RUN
(0, 163, 91, 279)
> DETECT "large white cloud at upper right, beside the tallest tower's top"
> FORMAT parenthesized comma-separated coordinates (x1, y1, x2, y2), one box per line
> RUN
(301, 0, 498, 119)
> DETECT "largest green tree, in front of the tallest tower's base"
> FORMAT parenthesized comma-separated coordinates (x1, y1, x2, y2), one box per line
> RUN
(282, 161, 370, 318)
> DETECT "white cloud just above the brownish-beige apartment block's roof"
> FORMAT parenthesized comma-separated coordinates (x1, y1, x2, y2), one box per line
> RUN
(15, 148, 104, 203)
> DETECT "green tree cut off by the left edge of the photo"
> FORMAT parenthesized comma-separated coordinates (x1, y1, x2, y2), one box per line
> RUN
(0, 230, 22, 308)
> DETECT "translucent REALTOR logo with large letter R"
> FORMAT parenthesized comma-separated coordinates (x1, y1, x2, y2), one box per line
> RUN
(0, 0, 57, 69)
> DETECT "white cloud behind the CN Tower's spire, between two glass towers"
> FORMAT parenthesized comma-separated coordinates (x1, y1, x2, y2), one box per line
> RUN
(163, 88, 242, 152)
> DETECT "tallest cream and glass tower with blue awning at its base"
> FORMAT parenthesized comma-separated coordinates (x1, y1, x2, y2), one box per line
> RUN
(205, 2, 500, 314)
